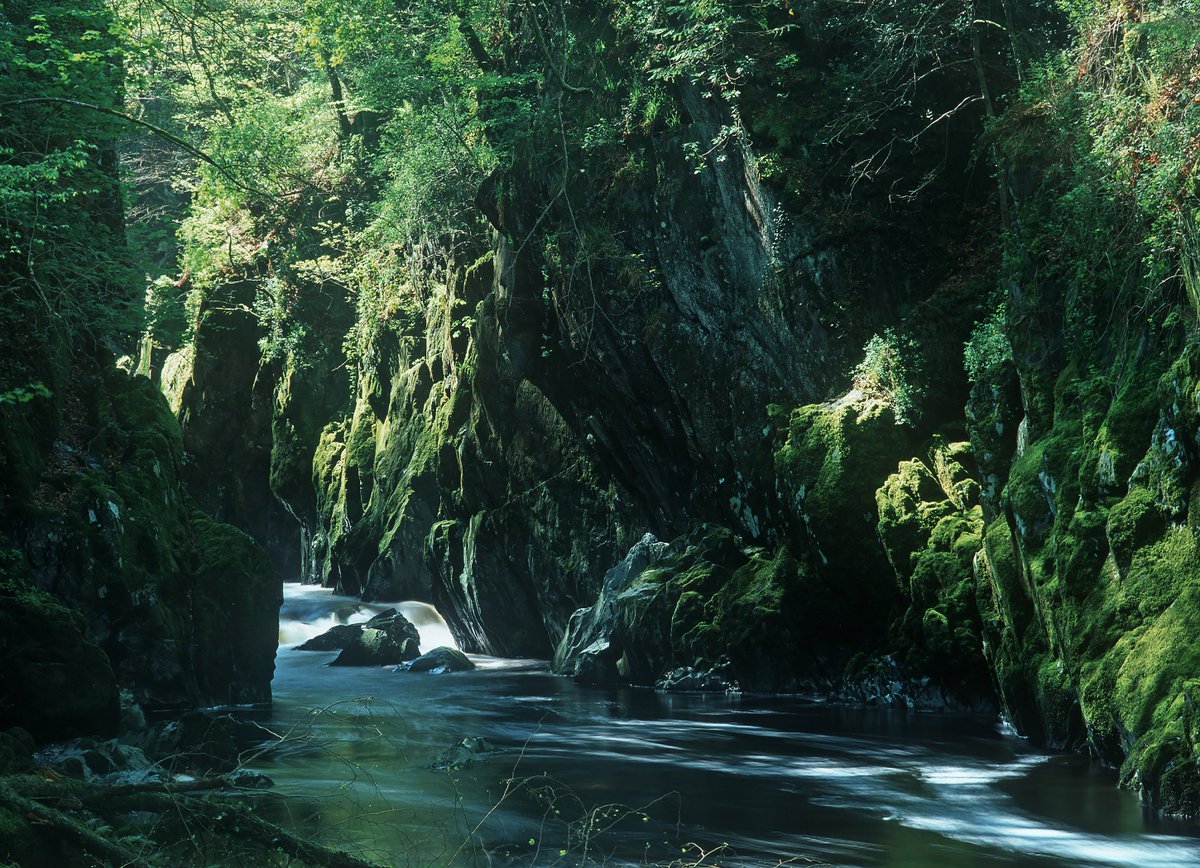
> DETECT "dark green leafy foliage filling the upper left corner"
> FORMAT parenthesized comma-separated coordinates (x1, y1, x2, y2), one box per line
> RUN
(0, 2, 139, 335)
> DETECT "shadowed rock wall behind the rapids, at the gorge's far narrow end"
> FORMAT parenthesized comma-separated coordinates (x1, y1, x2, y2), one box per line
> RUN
(160, 279, 352, 581)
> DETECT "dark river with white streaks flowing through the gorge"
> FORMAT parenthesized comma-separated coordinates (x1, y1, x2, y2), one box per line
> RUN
(265, 585, 1200, 868)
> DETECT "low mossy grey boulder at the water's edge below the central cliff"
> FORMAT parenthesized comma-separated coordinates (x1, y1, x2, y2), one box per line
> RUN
(554, 526, 857, 693)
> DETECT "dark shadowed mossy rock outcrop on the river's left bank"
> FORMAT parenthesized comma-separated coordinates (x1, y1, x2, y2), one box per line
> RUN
(0, 355, 282, 725)
